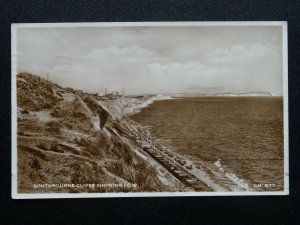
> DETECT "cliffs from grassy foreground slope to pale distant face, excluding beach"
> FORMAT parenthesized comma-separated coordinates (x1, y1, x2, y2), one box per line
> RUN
(17, 73, 182, 193)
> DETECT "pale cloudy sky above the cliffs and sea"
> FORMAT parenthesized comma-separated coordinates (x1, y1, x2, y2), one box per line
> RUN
(16, 26, 283, 95)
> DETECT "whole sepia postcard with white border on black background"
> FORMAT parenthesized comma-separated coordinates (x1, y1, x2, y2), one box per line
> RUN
(11, 22, 289, 199)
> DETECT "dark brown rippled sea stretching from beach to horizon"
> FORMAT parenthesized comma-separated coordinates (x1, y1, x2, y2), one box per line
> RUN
(131, 96, 284, 191)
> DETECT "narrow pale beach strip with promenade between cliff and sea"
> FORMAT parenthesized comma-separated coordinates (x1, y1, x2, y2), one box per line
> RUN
(104, 97, 251, 192)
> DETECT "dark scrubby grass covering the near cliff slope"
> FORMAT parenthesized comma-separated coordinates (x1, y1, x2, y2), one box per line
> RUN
(17, 73, 173, 193)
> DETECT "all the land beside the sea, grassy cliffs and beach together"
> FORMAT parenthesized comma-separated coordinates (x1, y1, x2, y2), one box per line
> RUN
(16, 73, 256, 193)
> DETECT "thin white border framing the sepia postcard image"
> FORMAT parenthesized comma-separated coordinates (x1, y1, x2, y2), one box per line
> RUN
(11, 21, 289, 199)
